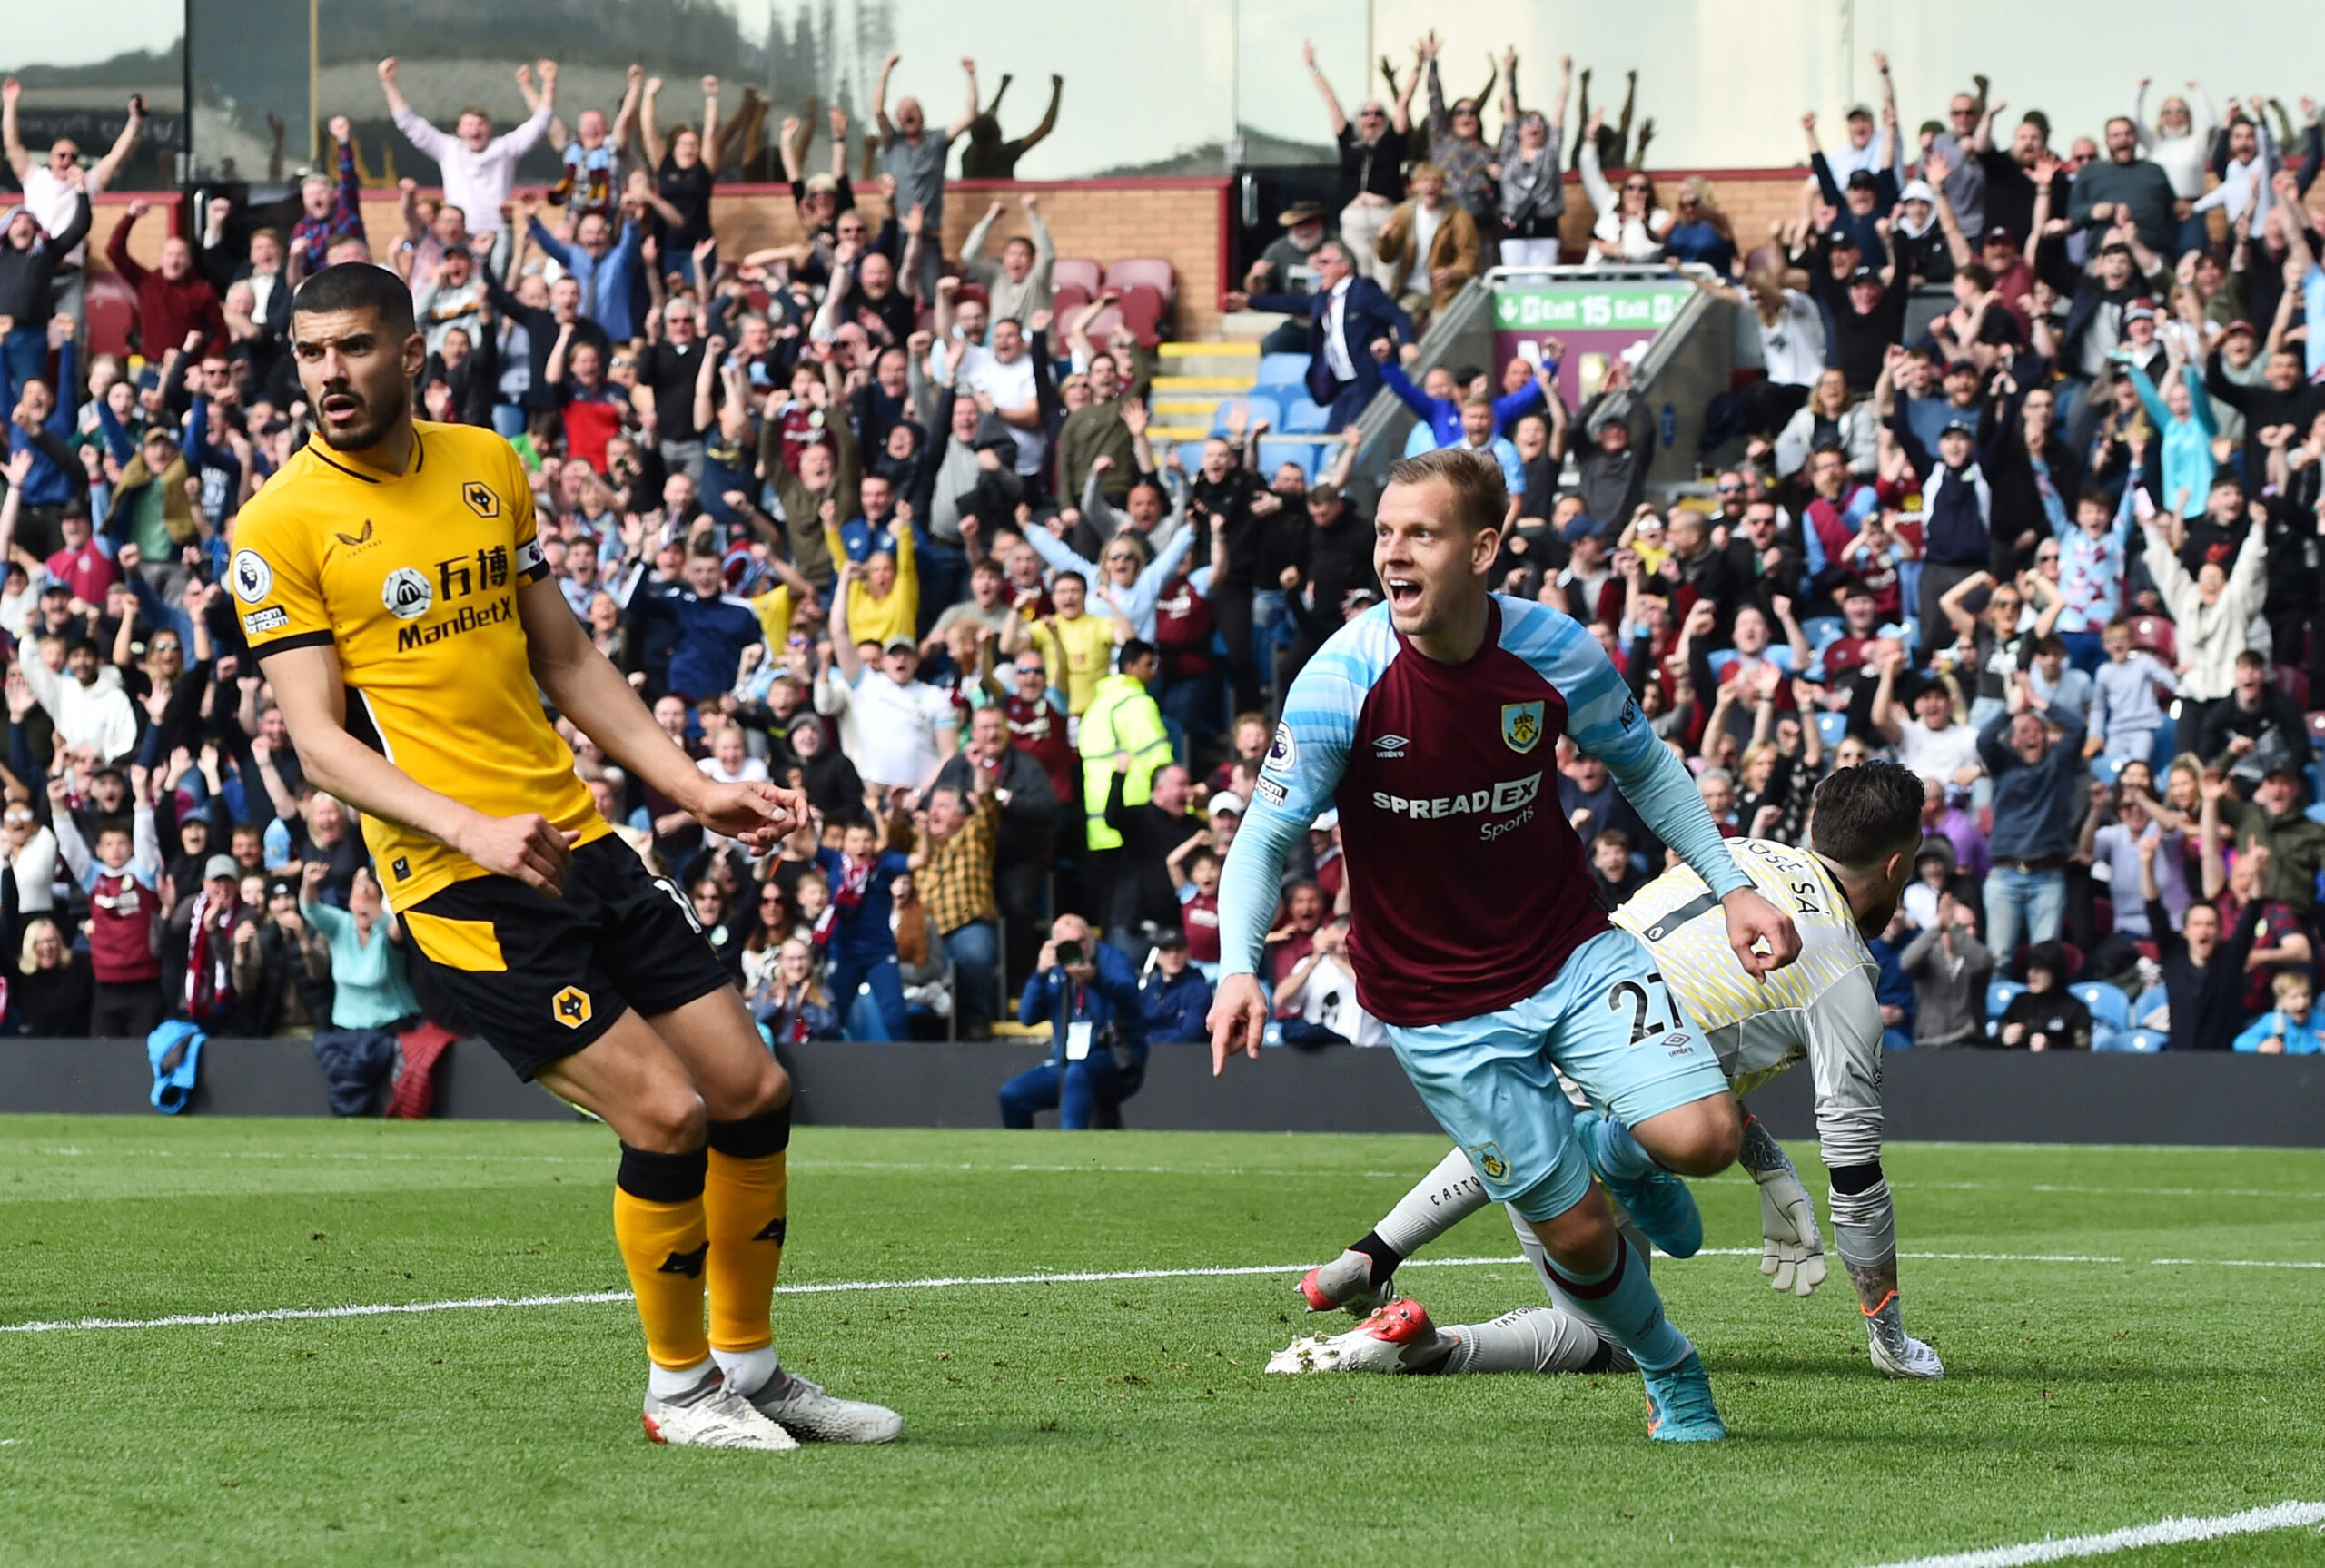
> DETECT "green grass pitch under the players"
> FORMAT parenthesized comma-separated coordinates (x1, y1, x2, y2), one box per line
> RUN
(0, 1118, 2325, 1568)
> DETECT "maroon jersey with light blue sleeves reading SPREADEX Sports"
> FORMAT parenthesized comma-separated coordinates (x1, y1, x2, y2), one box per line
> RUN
(1221, 595, 1748, 1029)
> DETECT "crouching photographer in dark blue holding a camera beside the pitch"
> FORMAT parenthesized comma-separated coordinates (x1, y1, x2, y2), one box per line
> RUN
(1000, 915, 1146, 1131)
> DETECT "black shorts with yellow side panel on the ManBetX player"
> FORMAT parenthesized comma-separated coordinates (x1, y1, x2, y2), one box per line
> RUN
(400, 834, 730, 1080)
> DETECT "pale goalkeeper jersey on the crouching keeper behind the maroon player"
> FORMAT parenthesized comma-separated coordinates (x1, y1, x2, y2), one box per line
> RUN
(1614, 839, 1881, 1166)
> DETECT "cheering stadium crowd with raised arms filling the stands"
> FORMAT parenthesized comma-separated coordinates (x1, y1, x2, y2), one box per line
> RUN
(0, 39, 2325, 1124)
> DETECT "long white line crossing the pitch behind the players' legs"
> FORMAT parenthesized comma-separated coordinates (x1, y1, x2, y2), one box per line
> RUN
(0, 1247, 2325, 1334)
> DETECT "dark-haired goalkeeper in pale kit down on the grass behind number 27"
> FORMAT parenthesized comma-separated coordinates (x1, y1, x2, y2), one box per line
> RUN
(1270, 762, 1944, 1377)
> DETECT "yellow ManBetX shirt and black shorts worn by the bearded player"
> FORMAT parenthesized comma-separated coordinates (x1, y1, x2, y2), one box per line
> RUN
(228, 423, 727, 1078)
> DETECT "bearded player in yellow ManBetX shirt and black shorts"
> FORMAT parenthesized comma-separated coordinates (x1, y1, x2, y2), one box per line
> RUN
(242, 262, 902, 1450)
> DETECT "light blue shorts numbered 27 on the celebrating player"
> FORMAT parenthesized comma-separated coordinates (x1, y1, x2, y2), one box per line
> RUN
(1388, 927, 1727, 1219)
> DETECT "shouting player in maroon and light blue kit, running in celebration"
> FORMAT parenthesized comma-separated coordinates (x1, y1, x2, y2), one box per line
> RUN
(1212, 449, 1799, 1443)
